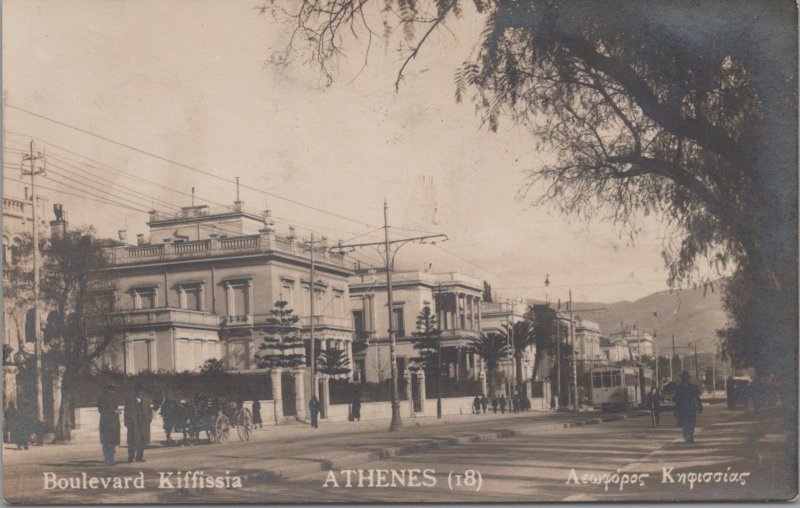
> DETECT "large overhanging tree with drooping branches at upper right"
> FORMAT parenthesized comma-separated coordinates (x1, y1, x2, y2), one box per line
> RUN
(265, 0, 798, 430)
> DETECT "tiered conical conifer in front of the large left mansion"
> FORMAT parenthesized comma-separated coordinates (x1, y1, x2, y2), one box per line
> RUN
(256, 300, 305, 369)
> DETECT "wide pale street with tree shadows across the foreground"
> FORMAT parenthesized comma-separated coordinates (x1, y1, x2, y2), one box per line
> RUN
(4, 404, 788, 503)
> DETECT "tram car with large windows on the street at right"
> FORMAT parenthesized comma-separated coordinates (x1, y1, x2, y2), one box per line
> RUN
(589, 366, 653, 411)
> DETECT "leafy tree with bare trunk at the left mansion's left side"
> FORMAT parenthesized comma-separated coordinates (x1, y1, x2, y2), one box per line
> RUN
(39, 229, 119, 442)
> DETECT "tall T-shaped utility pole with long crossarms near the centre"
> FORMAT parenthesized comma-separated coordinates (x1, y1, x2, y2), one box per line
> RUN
(330, 199, 447, 431)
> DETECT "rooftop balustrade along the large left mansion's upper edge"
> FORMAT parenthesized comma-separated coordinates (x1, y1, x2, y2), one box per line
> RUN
(107, 234, 345, 268)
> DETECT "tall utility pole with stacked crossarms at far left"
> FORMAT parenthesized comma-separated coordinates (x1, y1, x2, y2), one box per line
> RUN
(22, 139, 46, 422)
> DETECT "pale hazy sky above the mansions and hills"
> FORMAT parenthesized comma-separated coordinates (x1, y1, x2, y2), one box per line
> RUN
(3, 0, 684, 302)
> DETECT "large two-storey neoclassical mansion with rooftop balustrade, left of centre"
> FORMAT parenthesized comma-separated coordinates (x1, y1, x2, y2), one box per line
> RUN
(99, 202, 353, 373)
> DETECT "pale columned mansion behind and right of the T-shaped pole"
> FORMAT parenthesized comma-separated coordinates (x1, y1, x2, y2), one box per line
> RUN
(349, 269, 483, 382)
